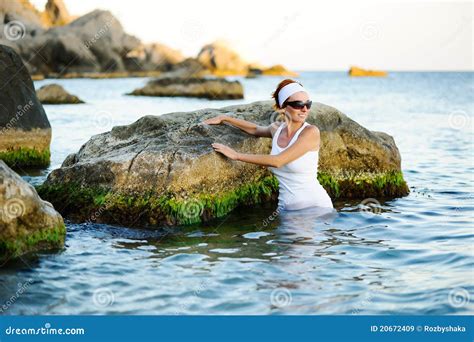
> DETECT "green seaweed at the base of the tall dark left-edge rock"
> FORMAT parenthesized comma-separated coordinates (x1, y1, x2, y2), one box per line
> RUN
(0, 147, 51, 167)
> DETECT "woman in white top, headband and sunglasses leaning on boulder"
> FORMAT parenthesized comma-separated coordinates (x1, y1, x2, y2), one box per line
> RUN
(204, 79, 333, 210)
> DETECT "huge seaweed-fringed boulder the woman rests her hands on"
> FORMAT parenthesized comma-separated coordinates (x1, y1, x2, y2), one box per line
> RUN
(39, 102, 408, 226)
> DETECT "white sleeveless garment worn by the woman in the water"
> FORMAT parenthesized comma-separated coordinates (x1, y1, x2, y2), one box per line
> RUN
(269, 122, 333, 210)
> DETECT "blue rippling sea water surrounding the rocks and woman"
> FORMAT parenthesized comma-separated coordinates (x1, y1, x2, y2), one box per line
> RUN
(0, 73, 474, 315)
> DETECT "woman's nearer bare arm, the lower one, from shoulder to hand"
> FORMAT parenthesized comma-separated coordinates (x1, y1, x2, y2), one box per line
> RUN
(212, 126, 320, 168)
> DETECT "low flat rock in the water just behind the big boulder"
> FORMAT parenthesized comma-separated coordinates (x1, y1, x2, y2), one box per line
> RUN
(129, 77, 244, 100)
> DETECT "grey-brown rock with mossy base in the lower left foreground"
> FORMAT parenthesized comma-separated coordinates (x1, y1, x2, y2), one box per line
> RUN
(0, 160, 66, 263)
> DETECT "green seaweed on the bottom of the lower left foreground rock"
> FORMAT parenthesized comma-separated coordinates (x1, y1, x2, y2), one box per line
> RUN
(0, 224, 66, 261)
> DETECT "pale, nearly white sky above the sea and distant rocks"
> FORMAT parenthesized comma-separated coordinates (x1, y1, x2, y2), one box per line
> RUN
(31, 0, 474, 71)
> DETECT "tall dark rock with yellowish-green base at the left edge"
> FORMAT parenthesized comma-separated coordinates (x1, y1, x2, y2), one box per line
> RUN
(0, 45, 51, 167)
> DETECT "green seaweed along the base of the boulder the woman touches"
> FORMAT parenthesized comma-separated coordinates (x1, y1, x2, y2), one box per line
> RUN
(37, 171, 408, 226)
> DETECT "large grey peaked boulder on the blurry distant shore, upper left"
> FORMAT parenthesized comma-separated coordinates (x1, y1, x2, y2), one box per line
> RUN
(3, 10, 140, 74)
